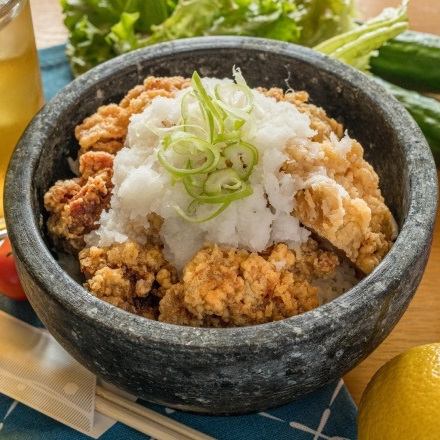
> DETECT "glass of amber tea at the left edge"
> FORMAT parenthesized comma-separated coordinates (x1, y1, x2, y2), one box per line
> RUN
(0, 0, 43, 229)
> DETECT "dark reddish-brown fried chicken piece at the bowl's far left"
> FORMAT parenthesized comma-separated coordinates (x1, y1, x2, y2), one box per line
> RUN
(44, 151, 113, 253)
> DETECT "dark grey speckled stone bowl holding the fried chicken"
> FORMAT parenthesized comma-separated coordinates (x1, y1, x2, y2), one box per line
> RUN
(6, 37, 437, 414)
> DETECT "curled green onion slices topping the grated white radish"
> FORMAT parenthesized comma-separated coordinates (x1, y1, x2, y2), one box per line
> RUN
(156, 68, 258, 223)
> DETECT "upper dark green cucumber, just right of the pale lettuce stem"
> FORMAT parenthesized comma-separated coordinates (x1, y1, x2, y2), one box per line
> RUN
(370, 31, 440, 92)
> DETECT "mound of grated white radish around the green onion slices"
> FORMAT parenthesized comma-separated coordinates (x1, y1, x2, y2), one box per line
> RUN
(85, 78, 351, 269)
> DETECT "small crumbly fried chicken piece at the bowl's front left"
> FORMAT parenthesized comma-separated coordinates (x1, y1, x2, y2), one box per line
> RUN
(79, 241, 167, 312)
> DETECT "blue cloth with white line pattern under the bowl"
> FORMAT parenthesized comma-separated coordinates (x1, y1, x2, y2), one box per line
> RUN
(0, 46, 356, 440)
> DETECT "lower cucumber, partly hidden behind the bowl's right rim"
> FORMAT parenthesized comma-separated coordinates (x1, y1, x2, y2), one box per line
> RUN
(374, 77, 440, 166)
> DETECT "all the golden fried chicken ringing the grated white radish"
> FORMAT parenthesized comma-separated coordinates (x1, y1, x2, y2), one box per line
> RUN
(44, 77, 397, 327)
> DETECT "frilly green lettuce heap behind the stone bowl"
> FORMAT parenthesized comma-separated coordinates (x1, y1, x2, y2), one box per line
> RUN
(61, 0, 353, 75)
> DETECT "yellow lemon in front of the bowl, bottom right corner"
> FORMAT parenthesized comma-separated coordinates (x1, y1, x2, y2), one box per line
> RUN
(358, 343, 440, 440)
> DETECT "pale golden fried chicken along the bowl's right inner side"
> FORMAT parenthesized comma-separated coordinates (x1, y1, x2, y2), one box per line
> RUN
(264, 89, 397, 273)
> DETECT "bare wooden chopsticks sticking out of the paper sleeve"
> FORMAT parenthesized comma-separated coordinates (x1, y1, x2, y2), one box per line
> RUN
(95, 386, 214, 440)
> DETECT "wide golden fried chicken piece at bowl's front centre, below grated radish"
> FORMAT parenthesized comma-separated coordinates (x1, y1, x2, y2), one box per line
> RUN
(159, 241, 338, 327)
